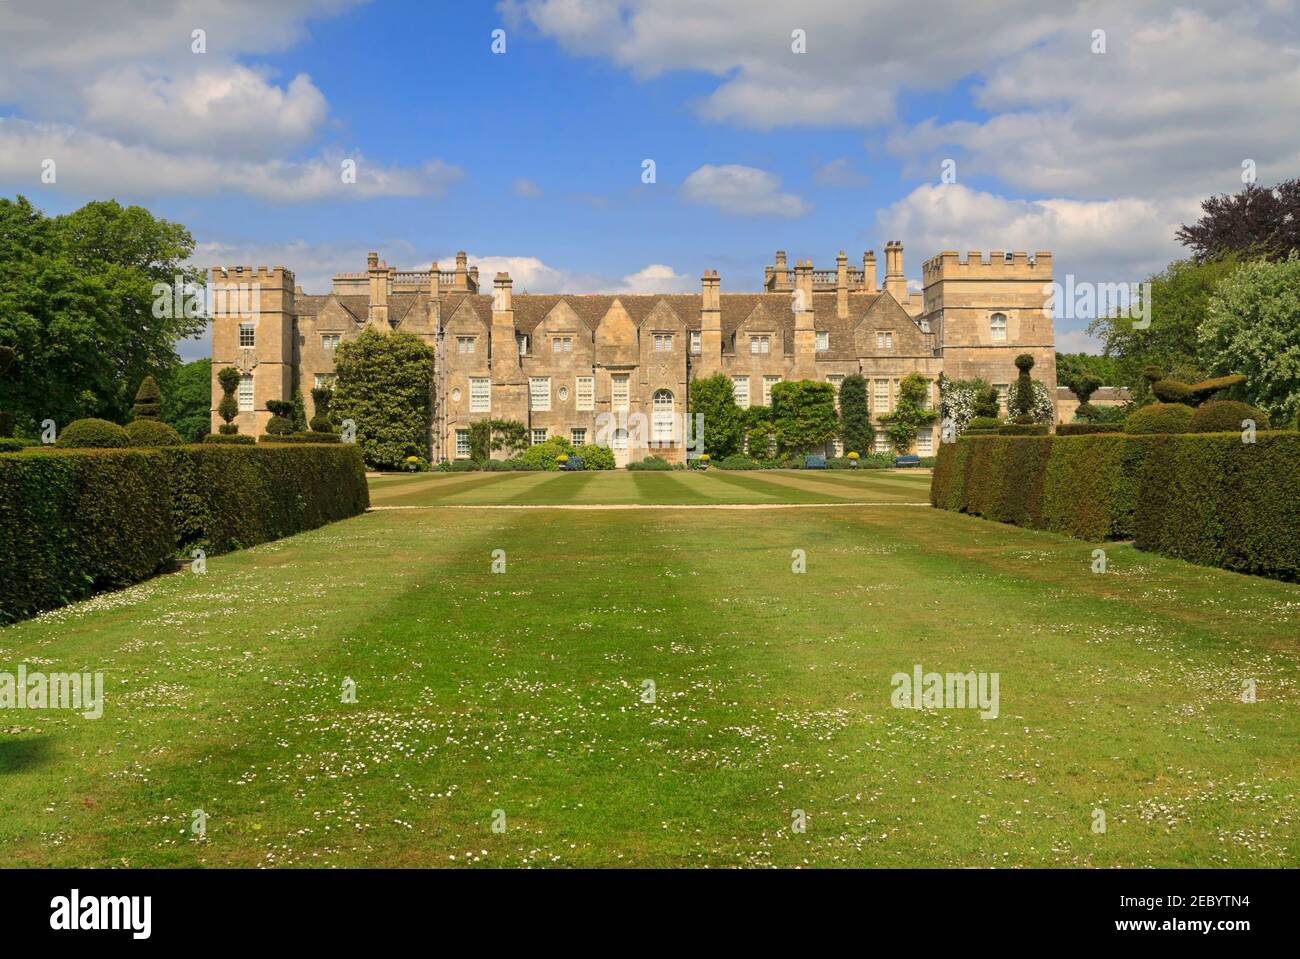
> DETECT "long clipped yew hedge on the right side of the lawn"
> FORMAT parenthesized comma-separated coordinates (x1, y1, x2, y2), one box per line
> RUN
(930, 431, 1300, 581)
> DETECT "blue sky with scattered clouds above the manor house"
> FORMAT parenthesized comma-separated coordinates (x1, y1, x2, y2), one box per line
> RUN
(0, 0, 1300, 356)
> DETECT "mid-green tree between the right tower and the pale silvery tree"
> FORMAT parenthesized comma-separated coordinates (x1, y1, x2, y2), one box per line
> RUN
(1088, 257, 1239, 403)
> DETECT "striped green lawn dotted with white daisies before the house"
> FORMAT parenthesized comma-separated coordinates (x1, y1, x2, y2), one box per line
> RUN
(0, 472, 1300, 867)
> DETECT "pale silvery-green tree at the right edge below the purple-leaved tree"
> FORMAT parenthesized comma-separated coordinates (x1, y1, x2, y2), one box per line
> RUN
(1199, 253, 1300, 422)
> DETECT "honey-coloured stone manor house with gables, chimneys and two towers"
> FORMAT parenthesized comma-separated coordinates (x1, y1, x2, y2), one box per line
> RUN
(212, 242, 1057, 465)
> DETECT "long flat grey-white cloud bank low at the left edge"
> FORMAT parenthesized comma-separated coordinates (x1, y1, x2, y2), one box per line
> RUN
(0, 117, 463, 203)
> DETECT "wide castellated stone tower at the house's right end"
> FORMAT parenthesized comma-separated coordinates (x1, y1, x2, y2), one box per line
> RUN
(922, 249, 1057, 399)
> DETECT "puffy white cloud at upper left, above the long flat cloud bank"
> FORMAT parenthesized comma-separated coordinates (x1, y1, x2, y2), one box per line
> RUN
(86, 65, 328, 157)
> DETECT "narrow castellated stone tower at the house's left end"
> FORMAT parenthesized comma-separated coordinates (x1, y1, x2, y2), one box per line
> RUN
(211, 266, 295, 437)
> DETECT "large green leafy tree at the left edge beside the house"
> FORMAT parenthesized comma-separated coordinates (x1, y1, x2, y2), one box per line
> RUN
(0, 196, 204, 430)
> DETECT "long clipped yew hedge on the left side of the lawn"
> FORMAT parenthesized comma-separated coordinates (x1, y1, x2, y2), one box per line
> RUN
(0, 444, 369, 622)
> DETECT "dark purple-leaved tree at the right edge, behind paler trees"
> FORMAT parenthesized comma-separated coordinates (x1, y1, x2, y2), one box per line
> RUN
(1177, 178, 1300, 261)
